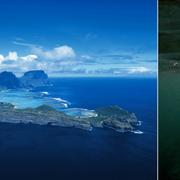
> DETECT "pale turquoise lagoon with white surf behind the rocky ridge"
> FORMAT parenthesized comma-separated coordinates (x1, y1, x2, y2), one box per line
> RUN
(0, 89, 97, 118)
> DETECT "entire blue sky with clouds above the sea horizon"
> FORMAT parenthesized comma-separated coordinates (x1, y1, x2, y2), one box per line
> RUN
(0, 0, 157, 77)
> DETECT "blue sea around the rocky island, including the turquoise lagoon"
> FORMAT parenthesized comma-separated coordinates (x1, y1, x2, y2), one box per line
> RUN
(0, 78, 157, 180)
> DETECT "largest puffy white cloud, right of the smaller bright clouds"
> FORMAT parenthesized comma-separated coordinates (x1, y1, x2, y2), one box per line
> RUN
(33, 45, 76, 60)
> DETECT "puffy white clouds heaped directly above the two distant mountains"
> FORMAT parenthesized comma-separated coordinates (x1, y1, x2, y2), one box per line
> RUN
(0, 46, 76, 74)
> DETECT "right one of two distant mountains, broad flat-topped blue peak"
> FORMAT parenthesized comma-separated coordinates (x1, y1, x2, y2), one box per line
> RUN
(20, 70, 49, 88)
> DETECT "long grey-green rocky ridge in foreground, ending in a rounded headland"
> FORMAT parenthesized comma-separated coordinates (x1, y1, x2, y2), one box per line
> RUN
(0, 102, 138, 132)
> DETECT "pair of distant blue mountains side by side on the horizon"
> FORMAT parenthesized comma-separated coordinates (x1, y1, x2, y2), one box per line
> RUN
(0, 70, 49, 89)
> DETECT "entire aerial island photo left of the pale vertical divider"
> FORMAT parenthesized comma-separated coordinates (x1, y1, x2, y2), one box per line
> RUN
(0, 0, 157, 180)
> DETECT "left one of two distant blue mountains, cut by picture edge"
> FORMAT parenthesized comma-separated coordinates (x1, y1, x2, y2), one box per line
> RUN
(0, 71, 20, 89)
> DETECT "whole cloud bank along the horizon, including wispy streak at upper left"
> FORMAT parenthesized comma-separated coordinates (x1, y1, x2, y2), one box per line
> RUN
(0, 42, 156, 76)
